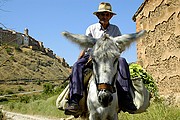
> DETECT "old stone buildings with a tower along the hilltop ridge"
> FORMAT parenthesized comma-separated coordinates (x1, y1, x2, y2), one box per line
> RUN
(0, 27, 69, 68)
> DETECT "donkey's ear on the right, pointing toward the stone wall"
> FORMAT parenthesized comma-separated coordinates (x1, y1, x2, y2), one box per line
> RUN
(113, 30, 146, 52)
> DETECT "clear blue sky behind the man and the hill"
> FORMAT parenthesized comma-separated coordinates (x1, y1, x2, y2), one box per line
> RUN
(0, 0, 144, 65)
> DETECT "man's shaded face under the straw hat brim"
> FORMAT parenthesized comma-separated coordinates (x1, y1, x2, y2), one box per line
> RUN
(96, 12, 113, 24)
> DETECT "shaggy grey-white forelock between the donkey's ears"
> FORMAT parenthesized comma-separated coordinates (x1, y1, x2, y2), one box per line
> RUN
(92, 37, 120, 59)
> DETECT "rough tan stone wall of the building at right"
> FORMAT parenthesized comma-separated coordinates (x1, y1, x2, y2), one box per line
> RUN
(133, 0, 180, 105)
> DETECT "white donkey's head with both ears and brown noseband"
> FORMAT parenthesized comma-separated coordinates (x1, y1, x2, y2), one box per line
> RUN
(62, 31, 145, 107)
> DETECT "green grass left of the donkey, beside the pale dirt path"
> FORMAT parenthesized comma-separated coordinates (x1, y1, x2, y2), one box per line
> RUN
(4, 95, 67, 118)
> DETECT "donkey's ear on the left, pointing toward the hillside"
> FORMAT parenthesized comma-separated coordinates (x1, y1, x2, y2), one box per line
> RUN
(62, 32, 97, 48)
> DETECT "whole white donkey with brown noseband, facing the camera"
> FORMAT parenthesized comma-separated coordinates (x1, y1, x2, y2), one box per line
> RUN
(62, 30, 145, 120)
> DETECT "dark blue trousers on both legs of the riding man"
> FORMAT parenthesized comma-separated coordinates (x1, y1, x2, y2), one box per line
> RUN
(70, 55, 130, 99)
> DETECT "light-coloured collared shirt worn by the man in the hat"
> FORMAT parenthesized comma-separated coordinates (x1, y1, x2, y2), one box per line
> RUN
(86, 23, 121, 39)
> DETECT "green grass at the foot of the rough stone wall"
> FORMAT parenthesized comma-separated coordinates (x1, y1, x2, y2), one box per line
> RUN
(119, 102, 180, 120)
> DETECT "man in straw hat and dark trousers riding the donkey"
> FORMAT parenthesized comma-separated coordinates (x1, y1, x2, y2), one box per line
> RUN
(65, 2, 136, 115)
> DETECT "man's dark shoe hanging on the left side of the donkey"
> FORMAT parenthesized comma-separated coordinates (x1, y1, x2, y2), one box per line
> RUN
(64, 103, 82, 116)
